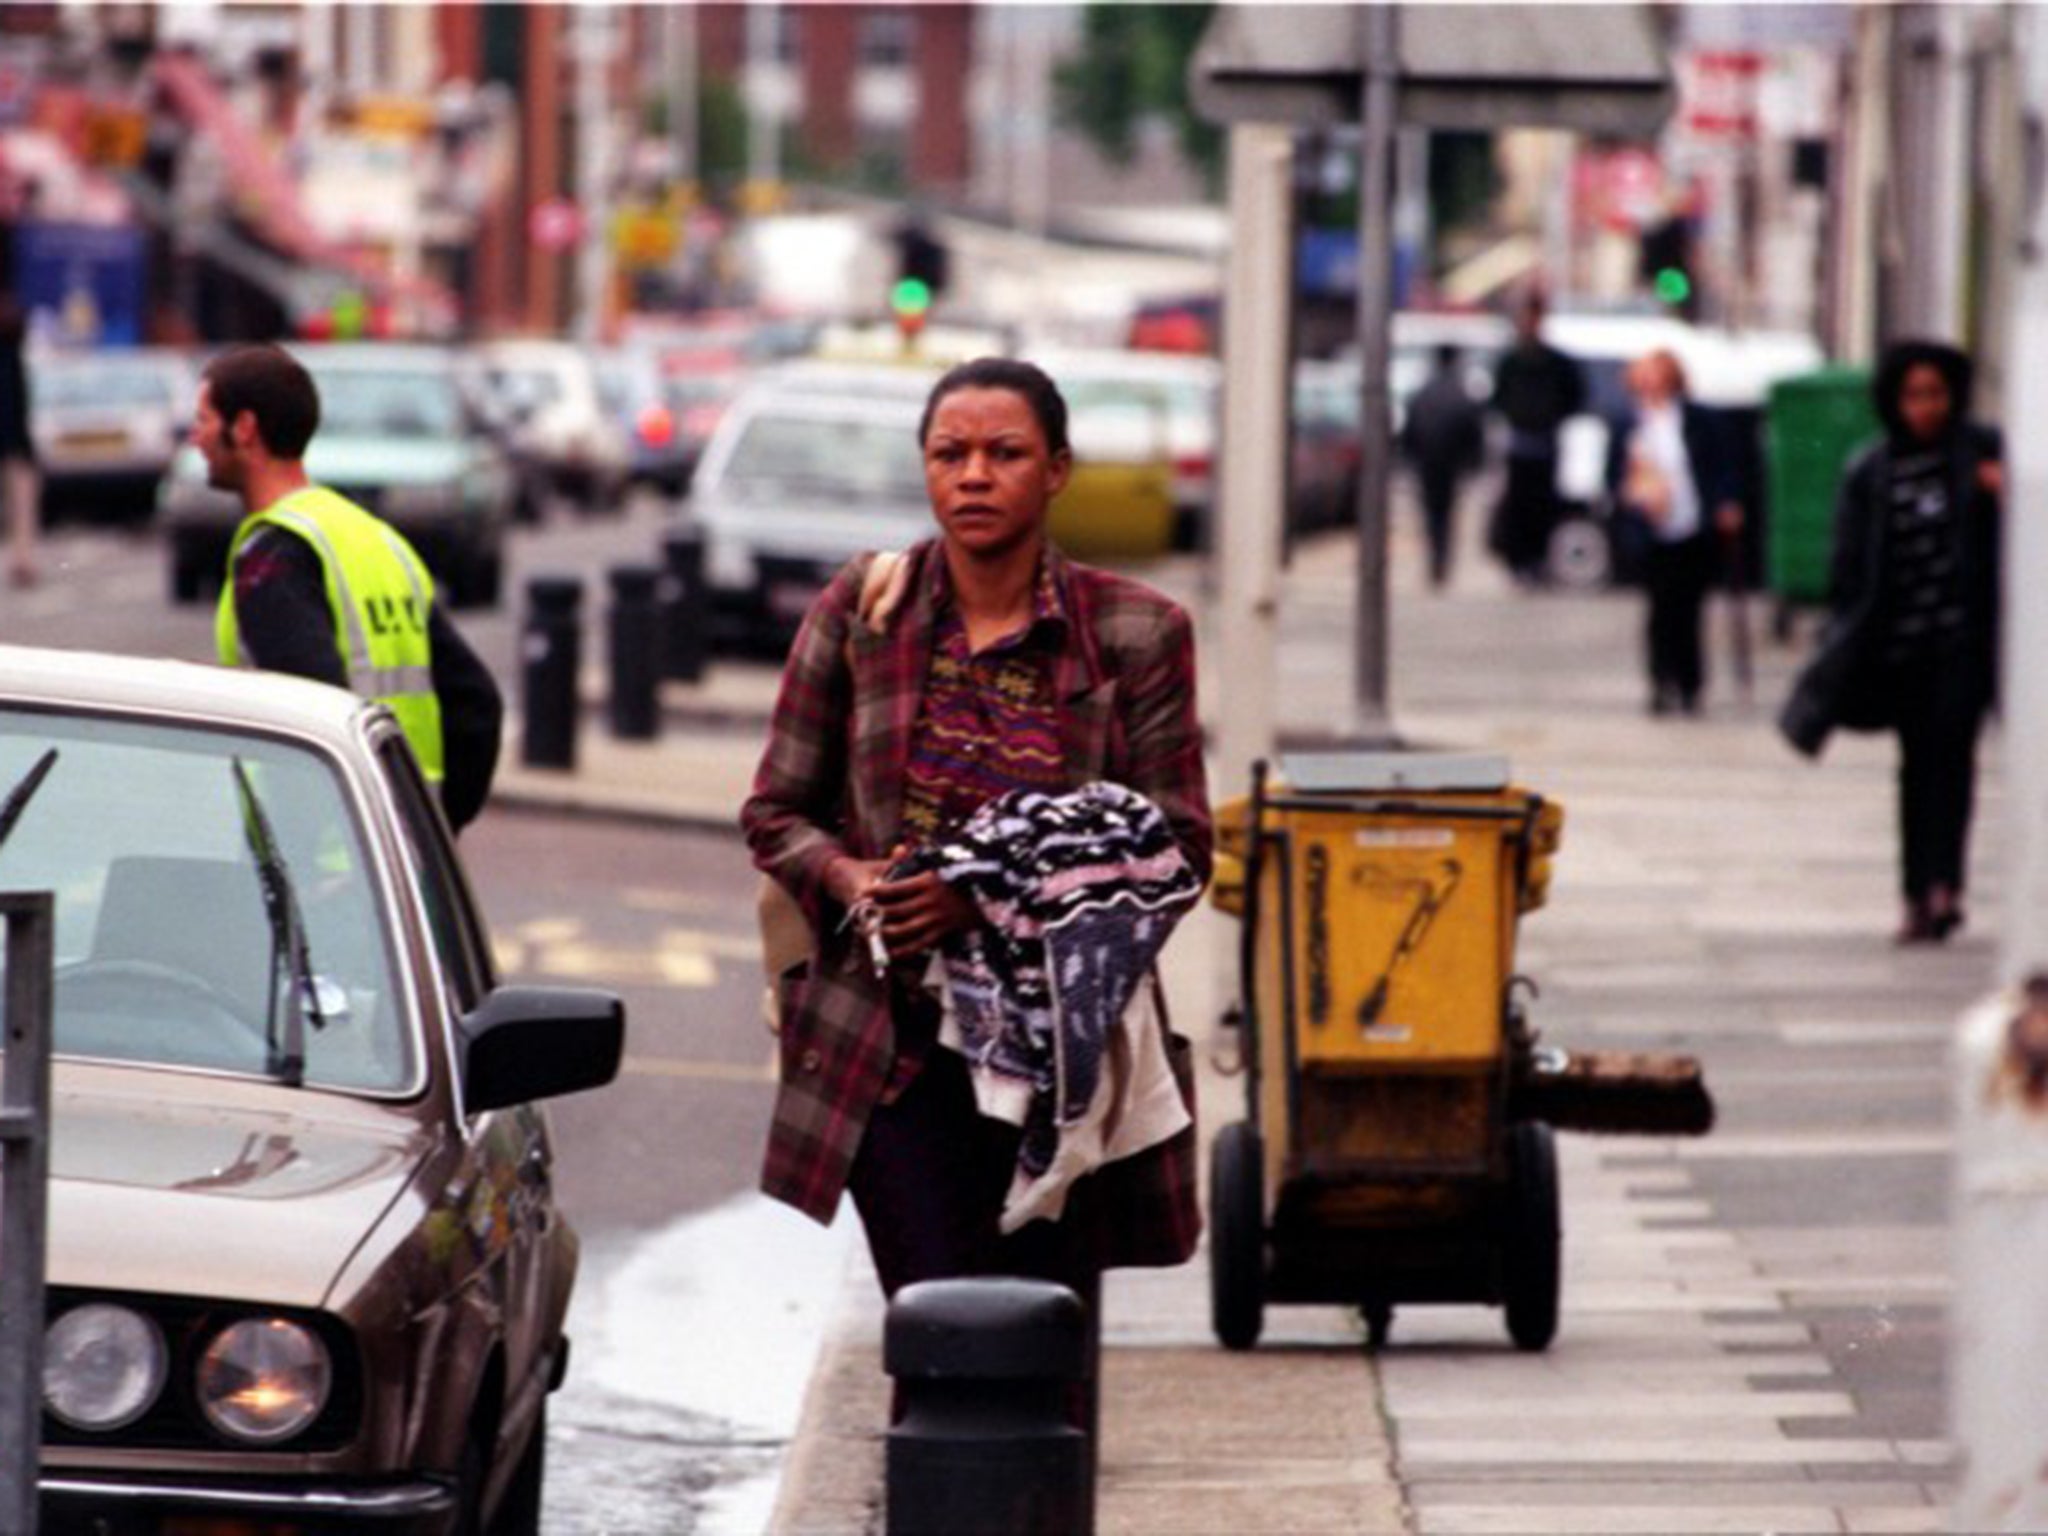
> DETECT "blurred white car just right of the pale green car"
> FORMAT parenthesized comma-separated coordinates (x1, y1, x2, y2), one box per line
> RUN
(475, 338, 633, 512)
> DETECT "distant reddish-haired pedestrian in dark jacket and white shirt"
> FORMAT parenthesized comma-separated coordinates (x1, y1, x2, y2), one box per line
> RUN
(1622, 350, 1743, 715)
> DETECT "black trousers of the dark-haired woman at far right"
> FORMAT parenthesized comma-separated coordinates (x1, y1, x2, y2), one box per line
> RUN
(1892, 659, 1985, 901)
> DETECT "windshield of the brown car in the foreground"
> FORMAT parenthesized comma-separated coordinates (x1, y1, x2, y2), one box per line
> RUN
(0, 711, 420, 1094)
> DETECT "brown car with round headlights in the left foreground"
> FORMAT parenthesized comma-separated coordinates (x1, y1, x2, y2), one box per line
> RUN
(0, 649, 625, 1536)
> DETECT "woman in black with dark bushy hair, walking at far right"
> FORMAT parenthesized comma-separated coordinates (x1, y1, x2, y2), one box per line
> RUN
(1780, 342, 2005, 944)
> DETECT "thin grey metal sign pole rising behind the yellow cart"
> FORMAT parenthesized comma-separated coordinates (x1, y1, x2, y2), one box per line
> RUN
(1352, 4, 1401, 741)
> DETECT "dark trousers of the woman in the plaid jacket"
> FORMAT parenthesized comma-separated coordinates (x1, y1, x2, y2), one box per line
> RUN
(848, 1044, 1102, 1434)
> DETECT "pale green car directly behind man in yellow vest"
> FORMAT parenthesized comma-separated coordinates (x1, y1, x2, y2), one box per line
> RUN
(158, 342, 516, 606)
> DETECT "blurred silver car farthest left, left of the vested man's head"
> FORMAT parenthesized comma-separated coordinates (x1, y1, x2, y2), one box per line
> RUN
(29, 346, 193, 522)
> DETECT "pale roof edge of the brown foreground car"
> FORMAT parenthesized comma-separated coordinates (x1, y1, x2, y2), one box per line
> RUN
(0, 645, 375, 748)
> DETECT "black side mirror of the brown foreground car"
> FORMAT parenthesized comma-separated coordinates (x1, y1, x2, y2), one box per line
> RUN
(457, 987, 627, 1114)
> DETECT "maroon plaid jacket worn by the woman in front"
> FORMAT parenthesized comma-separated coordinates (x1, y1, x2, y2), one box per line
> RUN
(739, 541, 1210, 1266)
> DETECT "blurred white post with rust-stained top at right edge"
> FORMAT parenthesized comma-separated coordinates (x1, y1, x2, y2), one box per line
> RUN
(1946, 977, 2048, 1532)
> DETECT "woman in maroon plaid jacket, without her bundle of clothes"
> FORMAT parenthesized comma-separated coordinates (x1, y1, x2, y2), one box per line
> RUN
(741, 358, 1210, 1335)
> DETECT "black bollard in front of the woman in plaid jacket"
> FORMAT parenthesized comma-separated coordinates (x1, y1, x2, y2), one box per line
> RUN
(883, 1280, 1096, 1536)
